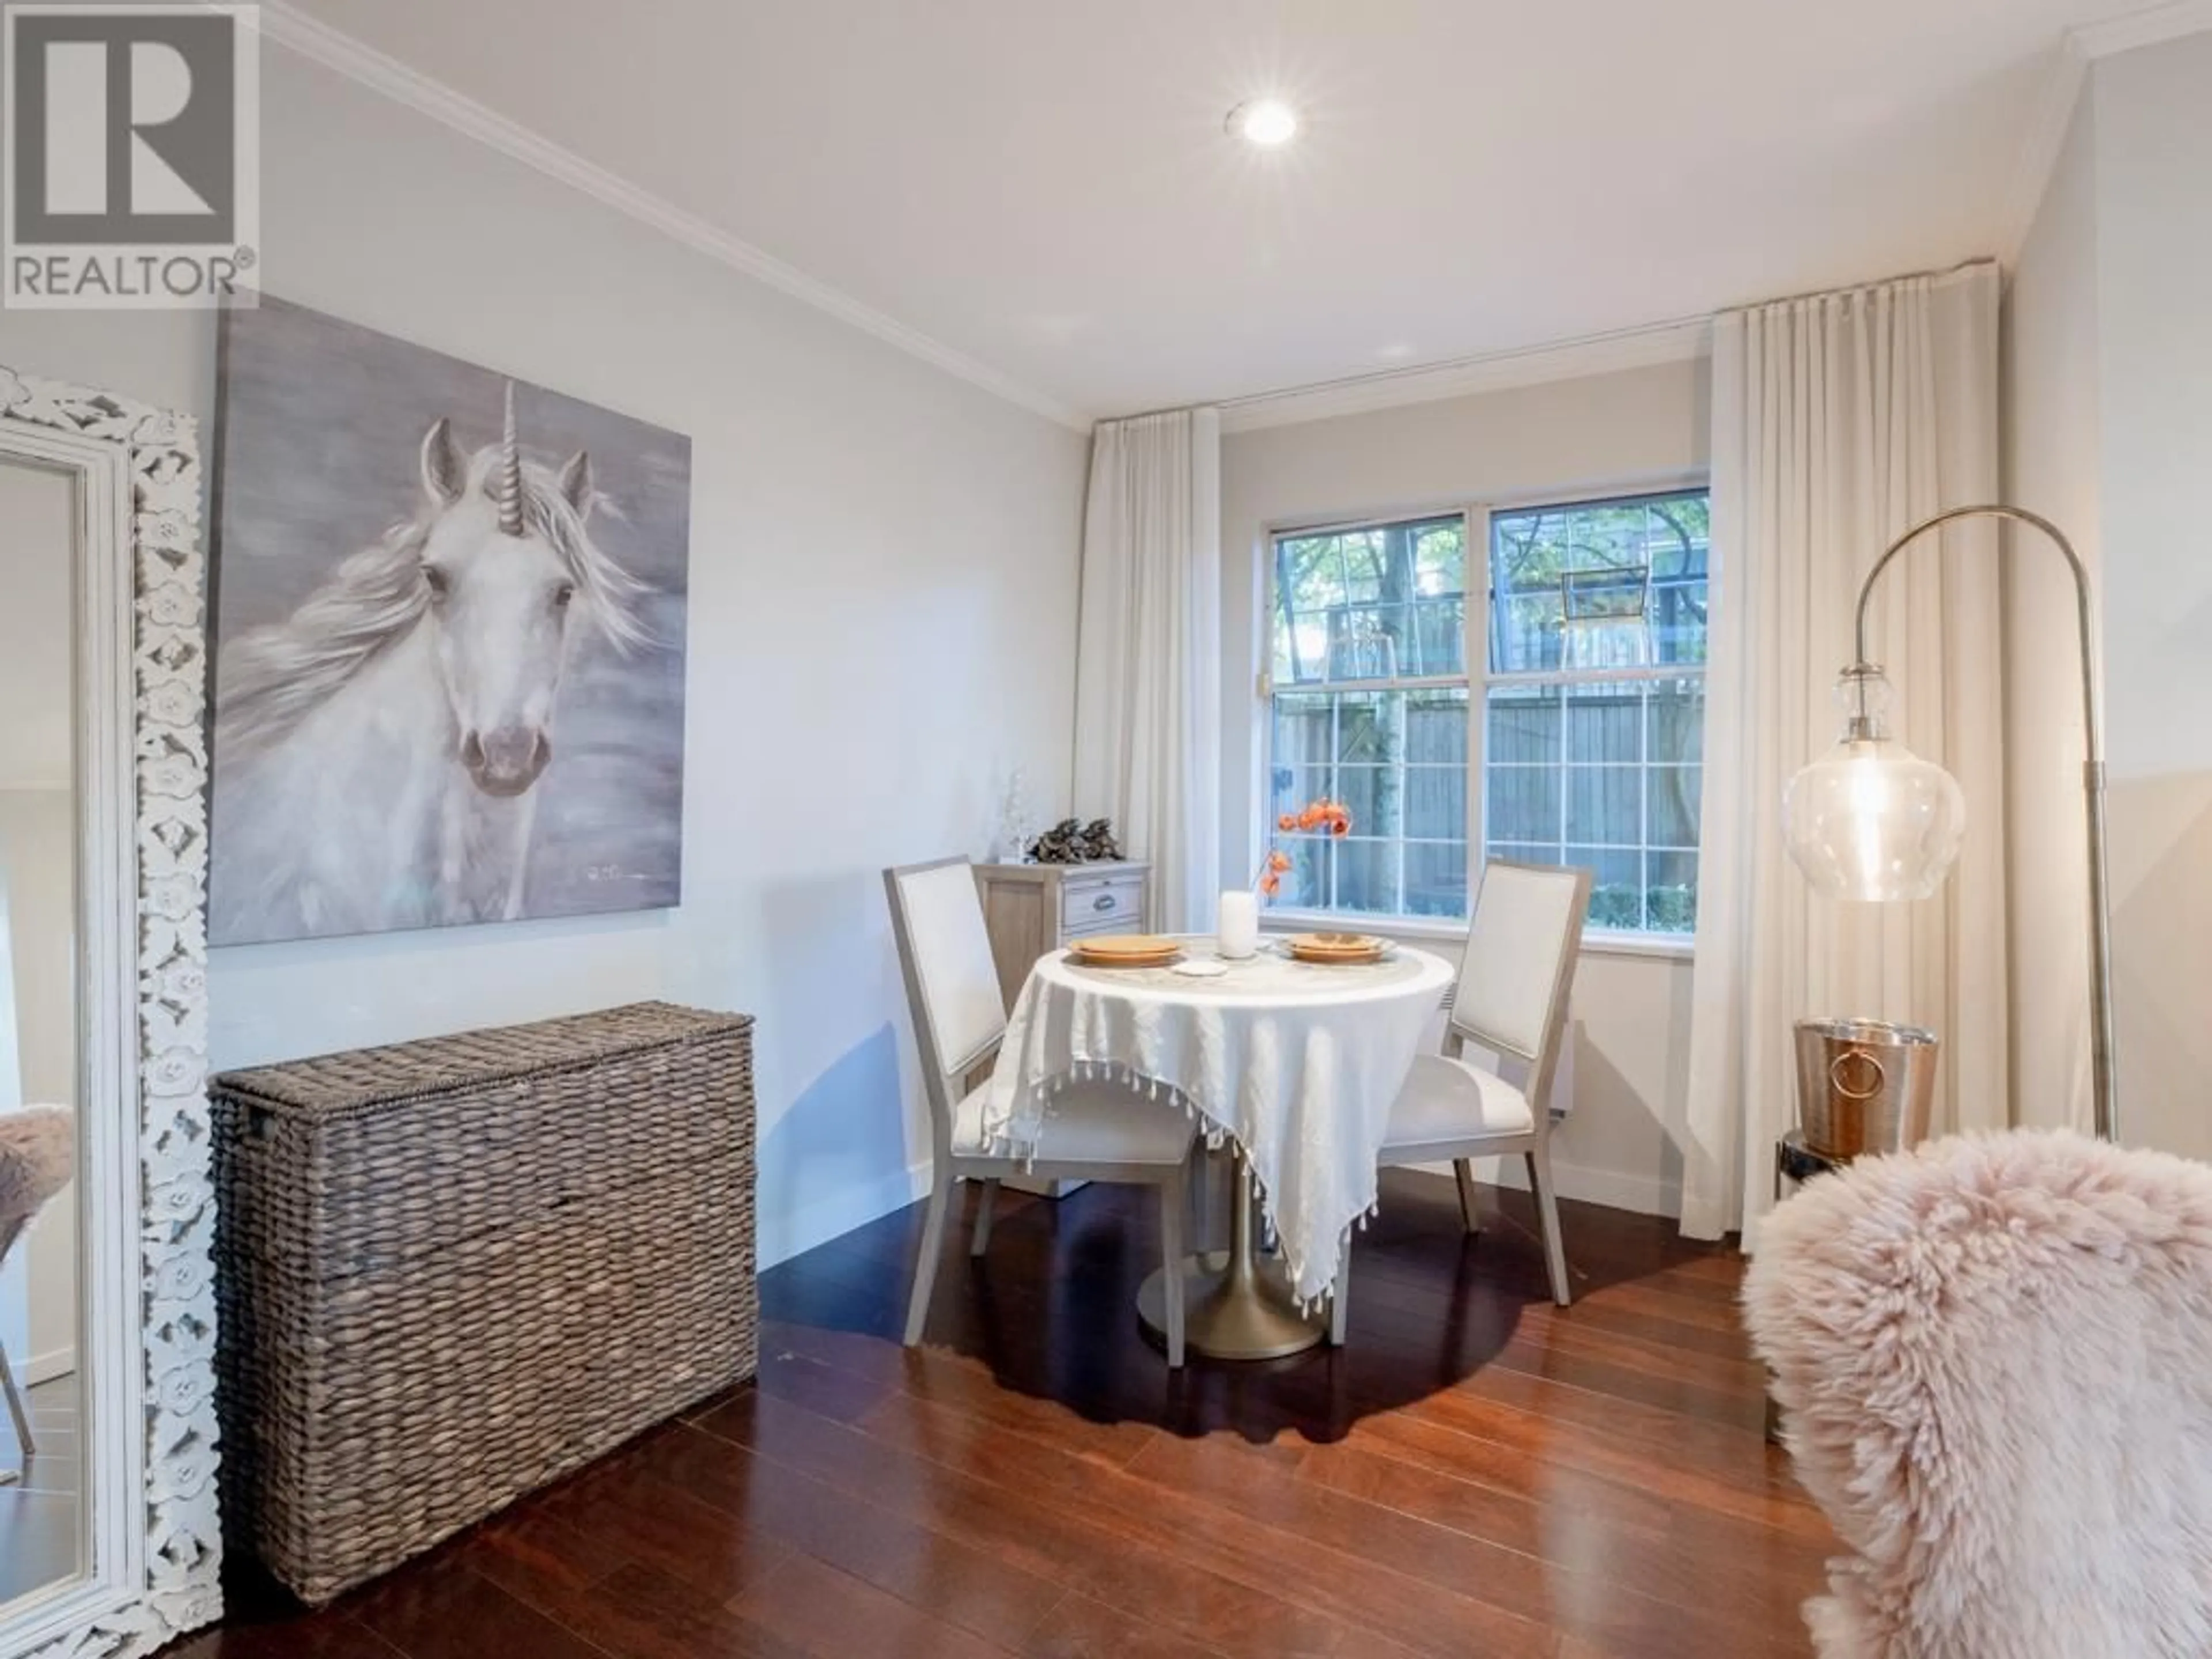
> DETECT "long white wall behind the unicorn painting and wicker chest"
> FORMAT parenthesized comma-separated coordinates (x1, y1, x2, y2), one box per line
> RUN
(0, 47, 1086, 1261)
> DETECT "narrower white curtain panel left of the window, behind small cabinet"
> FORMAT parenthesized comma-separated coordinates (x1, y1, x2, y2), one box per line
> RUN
(1075, 409, 1221, 931)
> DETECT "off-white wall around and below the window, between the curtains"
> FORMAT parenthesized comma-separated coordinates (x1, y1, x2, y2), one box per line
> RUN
(1221, 361, 1712, 1214)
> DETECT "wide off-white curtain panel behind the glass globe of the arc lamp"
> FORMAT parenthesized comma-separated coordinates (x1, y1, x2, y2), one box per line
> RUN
(1681, 263, 2009, 1248)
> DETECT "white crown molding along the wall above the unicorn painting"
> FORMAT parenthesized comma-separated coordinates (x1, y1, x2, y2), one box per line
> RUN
(244, 0, 1090, 431)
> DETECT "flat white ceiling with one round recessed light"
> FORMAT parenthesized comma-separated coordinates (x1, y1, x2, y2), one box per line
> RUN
(276, 0, 2141, 416)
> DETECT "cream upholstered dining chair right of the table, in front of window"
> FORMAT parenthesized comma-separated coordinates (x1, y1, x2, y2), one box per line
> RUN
(1332, 858, 1590, 1340)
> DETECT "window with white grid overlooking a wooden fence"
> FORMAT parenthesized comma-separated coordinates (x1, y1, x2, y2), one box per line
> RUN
(1265, 489, 1710, 933)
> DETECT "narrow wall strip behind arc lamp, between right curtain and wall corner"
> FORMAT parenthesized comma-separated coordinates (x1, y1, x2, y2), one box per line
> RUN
(2002, 89, 2104, 1130)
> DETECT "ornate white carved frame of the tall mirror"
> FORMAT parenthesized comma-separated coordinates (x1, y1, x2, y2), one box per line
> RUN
(0, 367, 221, 1659)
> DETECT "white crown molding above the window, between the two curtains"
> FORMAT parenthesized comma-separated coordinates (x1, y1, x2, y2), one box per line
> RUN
(1221, 316, 1712, 434)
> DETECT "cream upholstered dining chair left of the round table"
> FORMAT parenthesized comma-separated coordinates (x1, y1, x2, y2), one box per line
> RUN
(882, 858, 1195, 1367)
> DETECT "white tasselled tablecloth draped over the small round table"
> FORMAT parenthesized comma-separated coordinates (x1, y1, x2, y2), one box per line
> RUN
(984, 940, 1451, 1301)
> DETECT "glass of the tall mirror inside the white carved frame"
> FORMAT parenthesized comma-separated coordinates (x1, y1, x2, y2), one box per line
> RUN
(0, 456, 89, 1608)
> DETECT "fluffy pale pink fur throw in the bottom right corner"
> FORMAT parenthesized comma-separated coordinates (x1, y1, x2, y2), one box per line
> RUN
(1743, 1132, 2212, 1659)
